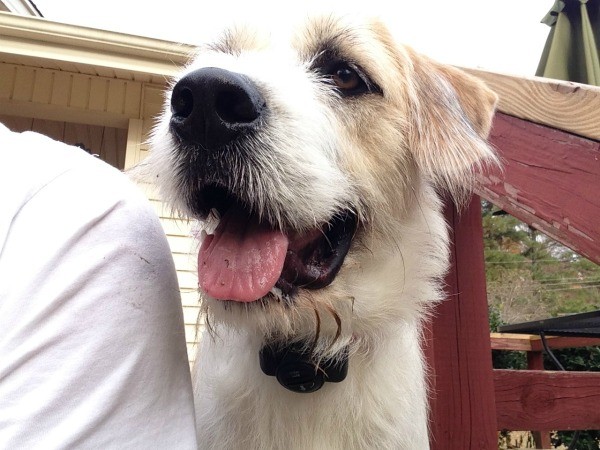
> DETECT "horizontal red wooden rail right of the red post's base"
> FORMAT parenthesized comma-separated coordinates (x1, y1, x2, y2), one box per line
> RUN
(489, 370, 600, 430)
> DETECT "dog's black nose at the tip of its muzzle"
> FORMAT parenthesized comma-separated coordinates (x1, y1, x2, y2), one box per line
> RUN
(171, 67, 265, 150)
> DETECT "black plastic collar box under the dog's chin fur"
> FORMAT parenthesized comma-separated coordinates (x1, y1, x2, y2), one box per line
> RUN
(258, 343, 348, 394)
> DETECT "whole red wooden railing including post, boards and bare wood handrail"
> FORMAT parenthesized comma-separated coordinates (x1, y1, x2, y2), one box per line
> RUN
(425, 72, 600, 450)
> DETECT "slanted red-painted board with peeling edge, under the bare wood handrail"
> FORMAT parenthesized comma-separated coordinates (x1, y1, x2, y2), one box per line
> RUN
(477, 113, 600, 263)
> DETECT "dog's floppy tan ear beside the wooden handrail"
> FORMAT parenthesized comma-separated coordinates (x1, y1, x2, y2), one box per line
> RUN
(409, 50, 498, 204)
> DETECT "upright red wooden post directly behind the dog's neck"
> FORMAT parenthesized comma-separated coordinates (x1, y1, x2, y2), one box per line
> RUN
(425, 196, 498, 450)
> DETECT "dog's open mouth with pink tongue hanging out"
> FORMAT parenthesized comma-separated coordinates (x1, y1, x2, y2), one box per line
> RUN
(198, 186, 357, 302)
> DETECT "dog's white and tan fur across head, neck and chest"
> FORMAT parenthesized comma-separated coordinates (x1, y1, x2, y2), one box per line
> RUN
(150, 13, 495, 450)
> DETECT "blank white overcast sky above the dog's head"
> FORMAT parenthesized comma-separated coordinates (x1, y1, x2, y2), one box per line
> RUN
(34, 0, 553, 75)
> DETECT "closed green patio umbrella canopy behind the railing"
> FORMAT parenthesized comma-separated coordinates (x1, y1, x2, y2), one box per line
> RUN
(536, 0, 600, 86)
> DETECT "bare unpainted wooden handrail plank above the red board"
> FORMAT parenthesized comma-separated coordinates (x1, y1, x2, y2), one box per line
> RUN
(464, 69, 600, 140)
